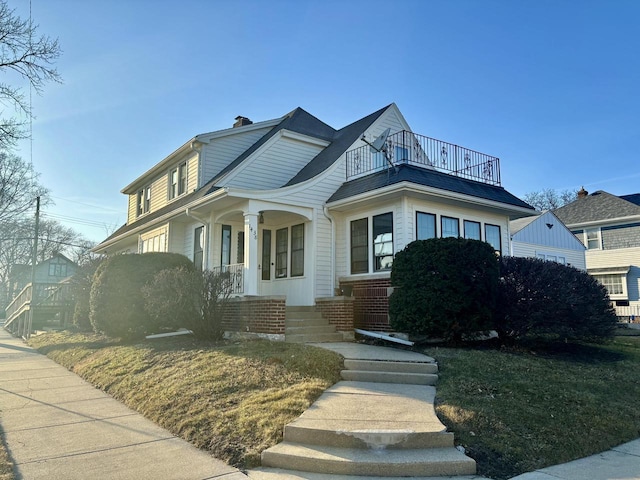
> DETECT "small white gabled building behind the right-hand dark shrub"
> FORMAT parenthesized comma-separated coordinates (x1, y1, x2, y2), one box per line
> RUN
(509, 211, 587, 270)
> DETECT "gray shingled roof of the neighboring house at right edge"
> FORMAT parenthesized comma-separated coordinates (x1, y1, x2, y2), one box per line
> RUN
(553, 190, 640, 225)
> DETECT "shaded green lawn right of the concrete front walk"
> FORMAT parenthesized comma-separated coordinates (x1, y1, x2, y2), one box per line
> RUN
(425, 337, 640, 480)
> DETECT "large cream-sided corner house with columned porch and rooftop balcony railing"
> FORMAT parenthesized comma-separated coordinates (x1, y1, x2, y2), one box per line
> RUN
(94, 104, 534, 334)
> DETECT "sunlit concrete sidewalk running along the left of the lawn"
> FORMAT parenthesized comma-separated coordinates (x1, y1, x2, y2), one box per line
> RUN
(0, 328, 247, 480)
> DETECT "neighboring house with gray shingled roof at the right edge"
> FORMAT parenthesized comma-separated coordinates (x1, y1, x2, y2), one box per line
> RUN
(554, 188, 640, 318)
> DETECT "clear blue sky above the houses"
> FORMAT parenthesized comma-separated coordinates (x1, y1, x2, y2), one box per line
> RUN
(8, 0, 640, 241)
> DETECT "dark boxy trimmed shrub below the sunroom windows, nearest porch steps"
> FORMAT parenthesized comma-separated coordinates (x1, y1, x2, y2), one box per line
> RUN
(389, 238, 499, 341)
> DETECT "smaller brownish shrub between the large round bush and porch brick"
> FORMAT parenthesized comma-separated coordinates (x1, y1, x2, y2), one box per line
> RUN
(142, 267, 231, 340)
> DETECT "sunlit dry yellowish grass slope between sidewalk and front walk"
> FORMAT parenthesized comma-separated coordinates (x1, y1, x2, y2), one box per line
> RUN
(31, 333, 342, 468)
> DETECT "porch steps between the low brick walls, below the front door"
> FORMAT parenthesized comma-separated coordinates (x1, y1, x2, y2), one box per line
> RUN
(284, 307, 344, 343)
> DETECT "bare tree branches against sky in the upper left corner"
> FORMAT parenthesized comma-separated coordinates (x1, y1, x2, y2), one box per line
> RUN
(0, 0, 62, 149)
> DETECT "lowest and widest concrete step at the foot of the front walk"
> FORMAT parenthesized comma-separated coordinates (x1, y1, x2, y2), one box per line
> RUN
(262, 442, 476, 477)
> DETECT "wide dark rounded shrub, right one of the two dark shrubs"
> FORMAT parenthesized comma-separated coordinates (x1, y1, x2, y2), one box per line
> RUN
(496, 257, 617, 340)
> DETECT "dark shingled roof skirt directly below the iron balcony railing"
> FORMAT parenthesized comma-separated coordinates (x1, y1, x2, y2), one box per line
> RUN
(328, 165, 535, 211)
